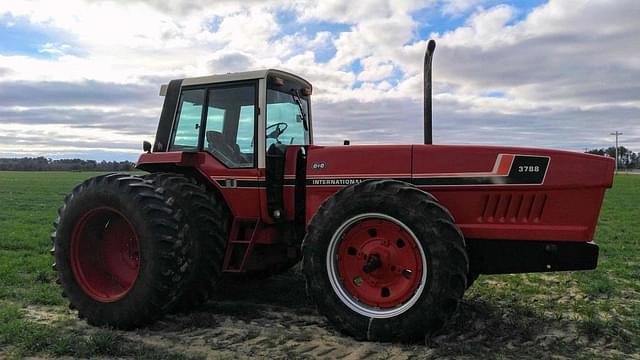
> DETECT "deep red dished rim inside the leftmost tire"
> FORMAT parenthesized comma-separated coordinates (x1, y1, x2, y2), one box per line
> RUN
(71, 207, 140, 302)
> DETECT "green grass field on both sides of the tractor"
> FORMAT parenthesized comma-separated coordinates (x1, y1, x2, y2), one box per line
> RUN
(0, 172, 640, 359)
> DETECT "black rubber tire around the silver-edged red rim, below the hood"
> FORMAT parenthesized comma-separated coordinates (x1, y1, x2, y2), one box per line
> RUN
(303, 180, 469, 341)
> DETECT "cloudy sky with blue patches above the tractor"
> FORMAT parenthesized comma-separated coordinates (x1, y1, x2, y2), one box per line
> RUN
(0, 0, 640, 160)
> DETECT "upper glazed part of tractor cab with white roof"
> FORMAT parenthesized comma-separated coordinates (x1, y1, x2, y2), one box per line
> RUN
(154, 70, 311, 169)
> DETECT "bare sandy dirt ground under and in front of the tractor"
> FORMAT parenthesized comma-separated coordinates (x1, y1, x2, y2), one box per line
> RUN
(21, 271, 640, 359)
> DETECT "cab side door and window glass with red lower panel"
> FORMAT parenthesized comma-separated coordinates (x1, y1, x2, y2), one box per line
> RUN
(172, 81, 260, 219)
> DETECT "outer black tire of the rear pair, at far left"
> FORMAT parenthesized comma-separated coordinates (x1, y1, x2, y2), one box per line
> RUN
(52, 174, 190, 329)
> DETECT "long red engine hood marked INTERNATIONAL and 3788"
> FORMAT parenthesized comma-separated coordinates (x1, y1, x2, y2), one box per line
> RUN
(306, 145, 615, 241)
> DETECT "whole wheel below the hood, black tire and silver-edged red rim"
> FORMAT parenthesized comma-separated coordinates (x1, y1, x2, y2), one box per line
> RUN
(303, 180, 468, 341)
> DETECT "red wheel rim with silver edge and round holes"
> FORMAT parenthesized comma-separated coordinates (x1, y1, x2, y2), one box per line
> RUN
(328, 214, 426, 317)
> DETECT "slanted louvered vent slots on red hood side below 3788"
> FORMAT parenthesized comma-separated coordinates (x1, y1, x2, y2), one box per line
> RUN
(478, 193, 547, 224)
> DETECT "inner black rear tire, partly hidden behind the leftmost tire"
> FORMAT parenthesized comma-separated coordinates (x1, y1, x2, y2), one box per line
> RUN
(144, 173, 231, 312)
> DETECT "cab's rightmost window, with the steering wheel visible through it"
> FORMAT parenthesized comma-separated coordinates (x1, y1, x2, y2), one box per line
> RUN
(266, 89, 309, 149)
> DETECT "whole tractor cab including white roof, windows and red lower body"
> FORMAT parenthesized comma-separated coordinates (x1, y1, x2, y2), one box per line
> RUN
(138, 70, 313, 228)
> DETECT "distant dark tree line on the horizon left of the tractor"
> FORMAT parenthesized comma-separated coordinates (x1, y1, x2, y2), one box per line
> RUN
(0, 156, 136, 171)
